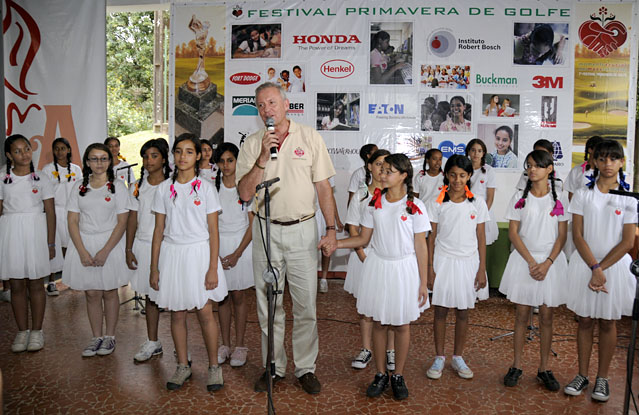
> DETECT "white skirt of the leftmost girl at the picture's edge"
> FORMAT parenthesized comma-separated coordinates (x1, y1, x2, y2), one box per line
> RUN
(0, 212, 51, 280)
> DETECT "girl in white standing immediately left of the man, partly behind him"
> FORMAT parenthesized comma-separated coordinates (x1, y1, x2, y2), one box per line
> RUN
(213, 143, 255, 367)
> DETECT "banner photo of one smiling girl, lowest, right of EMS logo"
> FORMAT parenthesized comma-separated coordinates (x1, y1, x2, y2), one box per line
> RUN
(477, 124, 519, 169)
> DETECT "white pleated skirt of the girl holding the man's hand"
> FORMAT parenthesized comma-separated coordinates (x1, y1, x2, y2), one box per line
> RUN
(357, 250, 430, 326)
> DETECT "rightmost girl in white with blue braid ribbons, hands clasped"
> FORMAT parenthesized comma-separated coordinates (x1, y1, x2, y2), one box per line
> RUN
(564, 140, 637, 402)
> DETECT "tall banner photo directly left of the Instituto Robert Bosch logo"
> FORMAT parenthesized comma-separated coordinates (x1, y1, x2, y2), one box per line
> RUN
(370, 22, 413, 85)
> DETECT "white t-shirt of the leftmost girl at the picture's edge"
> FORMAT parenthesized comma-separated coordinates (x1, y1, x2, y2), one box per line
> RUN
(0, 168, 54, 215)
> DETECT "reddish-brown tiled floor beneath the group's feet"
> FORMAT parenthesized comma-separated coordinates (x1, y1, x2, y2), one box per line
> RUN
(0, 281, 639, 414)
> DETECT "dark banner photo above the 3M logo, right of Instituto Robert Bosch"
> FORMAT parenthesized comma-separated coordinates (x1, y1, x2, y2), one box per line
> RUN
(513, 23, 570, 65)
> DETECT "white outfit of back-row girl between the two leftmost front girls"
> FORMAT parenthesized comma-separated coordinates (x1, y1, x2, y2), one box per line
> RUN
(42, 163, 82, 273)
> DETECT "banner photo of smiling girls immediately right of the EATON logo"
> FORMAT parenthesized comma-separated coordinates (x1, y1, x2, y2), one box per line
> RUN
(421, 92, 472, 133)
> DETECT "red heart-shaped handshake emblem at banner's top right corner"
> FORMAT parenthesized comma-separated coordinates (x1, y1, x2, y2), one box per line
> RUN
(579, 6, 628, 58)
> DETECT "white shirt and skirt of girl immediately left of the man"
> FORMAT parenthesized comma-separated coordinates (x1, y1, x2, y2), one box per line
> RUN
(218, 181, 255, 291)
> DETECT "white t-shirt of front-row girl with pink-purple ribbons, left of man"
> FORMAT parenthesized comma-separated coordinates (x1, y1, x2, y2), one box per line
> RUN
(151, 176, 222, 244)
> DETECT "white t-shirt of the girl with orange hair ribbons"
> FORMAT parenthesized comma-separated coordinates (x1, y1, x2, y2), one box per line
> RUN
(428, 197, 489, 258)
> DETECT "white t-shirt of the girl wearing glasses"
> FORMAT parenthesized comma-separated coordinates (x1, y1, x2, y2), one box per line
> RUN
(67, 180, 129, 234)
